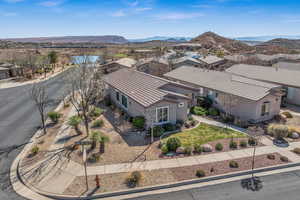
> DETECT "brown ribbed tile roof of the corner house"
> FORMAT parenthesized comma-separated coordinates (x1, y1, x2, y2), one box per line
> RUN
(104, 68, 186, 107)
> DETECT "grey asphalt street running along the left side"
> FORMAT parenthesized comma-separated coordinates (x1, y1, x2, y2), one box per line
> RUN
(0, 71, 68, 200)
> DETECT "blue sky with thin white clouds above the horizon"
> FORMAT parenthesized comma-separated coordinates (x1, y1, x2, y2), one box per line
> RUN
(0, 0, 300, 39)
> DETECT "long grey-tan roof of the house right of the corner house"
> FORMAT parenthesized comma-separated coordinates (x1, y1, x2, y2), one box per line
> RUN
(164, 66, 279, 101)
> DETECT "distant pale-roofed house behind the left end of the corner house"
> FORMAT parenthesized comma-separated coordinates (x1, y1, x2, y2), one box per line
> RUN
(100, 58, 137, 74)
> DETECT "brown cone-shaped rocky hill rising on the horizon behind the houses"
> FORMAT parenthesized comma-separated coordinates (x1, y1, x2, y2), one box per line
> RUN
(191, 32, 255, 53)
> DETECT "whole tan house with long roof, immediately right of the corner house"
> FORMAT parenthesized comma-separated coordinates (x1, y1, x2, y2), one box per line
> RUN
(165, 66, 282, 123)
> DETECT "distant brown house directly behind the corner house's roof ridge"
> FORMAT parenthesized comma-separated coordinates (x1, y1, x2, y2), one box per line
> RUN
(136, 57, 171, 77)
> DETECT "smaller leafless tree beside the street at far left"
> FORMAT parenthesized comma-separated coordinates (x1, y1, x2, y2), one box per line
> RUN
(30, 83, 49, 134)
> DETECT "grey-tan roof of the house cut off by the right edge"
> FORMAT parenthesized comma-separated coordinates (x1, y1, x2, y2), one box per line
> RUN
(226, 64, 300, 88)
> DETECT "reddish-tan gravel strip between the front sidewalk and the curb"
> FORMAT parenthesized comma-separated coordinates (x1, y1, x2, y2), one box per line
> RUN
(64, 153, 287, 195)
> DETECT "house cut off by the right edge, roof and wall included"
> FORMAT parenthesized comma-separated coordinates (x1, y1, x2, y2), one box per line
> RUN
(226, 64, 300, 105)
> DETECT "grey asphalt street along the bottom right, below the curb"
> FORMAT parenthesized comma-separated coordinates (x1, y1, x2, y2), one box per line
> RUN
(131, 171, 300, 200)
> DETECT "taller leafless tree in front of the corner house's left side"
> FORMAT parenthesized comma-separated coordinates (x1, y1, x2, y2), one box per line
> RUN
(66, 55, 103, 136)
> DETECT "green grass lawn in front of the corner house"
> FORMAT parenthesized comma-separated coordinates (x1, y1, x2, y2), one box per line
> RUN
(163, 123, 246, 146)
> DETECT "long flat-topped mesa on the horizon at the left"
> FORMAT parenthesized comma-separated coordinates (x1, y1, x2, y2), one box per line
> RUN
(2, 35, 128, 44)
